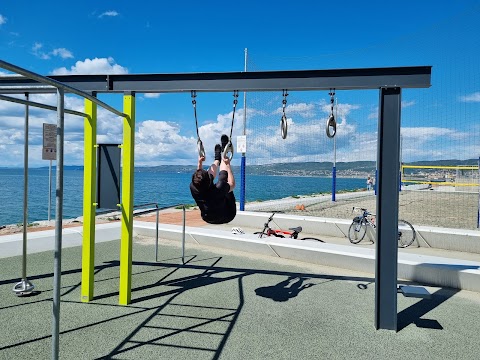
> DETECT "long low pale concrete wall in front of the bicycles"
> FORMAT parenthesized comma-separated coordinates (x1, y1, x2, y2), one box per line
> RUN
(134, 221, 480, 292)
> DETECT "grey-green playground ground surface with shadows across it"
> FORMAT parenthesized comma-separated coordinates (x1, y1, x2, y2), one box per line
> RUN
(0, 237, 480, 360)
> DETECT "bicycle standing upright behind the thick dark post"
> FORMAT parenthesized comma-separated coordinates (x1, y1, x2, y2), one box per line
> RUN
(348, 207, 417, 248)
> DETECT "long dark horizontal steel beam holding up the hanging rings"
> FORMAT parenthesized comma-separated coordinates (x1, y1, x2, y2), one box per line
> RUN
(0, 66, 432, 93)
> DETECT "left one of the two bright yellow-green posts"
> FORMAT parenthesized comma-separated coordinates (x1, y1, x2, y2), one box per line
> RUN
(81, 95, 97, 302)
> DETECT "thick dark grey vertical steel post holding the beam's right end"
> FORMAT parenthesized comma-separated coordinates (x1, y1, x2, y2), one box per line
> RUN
(375, 88, 401, 330)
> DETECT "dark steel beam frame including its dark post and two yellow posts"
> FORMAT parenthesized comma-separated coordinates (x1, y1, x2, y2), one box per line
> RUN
(0, 61, 431, 338)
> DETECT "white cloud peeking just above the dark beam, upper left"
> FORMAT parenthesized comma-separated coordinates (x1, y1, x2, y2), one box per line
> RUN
(52, 57, 128, 75)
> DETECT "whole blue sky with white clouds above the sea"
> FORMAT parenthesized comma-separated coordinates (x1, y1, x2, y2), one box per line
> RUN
(0, 0, 480, 166)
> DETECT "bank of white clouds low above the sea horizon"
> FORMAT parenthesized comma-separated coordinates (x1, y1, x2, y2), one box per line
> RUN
(0, 86, 474, 166)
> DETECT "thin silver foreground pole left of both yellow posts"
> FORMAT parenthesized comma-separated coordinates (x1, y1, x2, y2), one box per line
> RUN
(52, 89, 65, 360)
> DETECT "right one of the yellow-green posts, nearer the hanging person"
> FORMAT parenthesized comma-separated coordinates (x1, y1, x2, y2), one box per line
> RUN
(119, 93, 135, 305)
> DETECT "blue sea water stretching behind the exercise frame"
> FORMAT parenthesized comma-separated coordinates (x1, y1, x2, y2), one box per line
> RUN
(0, 168, 366, 225)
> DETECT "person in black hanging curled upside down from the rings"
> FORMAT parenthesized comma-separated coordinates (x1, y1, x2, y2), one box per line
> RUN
(190, 135, 237, 224)
